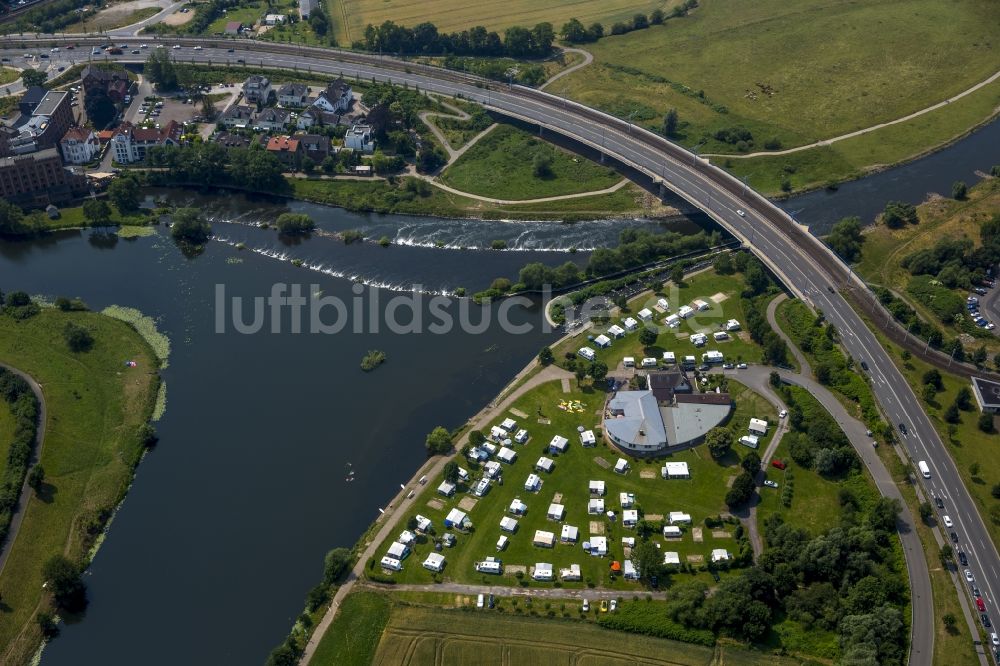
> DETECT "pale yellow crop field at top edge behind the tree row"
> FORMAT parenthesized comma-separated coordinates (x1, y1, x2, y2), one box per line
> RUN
(328, 0, 680, 45)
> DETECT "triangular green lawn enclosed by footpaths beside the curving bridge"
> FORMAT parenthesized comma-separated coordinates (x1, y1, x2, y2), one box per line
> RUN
(440, 125, 622, 199)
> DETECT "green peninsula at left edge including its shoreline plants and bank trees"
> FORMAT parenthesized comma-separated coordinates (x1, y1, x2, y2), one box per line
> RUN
(0, 292, 166, 664)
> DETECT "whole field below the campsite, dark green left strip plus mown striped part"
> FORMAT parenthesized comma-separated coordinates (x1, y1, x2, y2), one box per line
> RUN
(312, 590, 801, 666)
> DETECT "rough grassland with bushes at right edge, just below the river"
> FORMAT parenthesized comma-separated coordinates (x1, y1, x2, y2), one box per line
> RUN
(856, 178, 1000, 356)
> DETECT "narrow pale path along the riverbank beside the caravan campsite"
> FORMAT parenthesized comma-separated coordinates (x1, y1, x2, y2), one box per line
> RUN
(299, 360, 574, 666)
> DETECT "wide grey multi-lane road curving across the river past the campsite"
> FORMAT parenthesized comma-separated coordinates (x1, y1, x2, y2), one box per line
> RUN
(0, 36, 1000, 663)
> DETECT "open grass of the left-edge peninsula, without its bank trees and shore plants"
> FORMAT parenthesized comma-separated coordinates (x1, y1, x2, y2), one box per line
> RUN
(0, 309, 158, 664)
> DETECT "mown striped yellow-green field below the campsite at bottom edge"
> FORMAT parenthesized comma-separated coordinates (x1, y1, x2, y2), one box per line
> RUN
(370, 596, 800, 666)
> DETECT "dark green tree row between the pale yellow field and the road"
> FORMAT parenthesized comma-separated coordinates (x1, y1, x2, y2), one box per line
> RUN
(354, 21, 555, 58)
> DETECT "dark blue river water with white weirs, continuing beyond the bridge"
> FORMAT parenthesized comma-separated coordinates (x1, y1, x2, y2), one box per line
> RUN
(0, 116, 1000, 666)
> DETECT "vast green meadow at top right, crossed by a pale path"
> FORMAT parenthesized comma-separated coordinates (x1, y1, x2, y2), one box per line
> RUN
(551, 0, 1000, 193)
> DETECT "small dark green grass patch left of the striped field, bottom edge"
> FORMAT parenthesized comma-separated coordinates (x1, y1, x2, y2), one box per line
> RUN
(310, 590, 392, 666)
